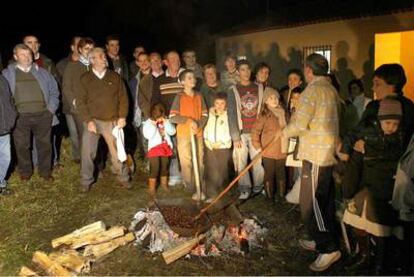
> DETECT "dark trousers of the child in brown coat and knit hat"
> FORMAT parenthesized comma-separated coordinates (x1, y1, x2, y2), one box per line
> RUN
(262, 157, 286, 198)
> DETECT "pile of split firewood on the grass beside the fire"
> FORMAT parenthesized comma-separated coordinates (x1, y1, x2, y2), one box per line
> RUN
(19, 221, 135, 276)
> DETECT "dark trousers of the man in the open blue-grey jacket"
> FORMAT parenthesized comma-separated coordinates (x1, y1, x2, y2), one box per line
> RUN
(13, 111, 53, 177)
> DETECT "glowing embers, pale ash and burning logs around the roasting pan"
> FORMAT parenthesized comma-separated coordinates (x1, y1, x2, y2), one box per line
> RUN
(130, 207, 267, 263)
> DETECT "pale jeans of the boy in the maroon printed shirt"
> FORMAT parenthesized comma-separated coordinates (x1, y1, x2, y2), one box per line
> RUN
(233, 134, 264, 192)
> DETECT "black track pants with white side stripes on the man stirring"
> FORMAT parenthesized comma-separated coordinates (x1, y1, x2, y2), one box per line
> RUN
(299, 161, 339, 253)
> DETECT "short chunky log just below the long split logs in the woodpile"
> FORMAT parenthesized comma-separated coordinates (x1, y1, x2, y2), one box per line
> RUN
(49, 250, 91, 273)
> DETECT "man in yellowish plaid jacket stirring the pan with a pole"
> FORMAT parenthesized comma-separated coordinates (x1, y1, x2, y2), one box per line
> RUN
(282, 54, 341, 271)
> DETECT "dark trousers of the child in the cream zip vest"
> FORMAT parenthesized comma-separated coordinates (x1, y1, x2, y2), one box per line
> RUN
(204, 147, 234, 197)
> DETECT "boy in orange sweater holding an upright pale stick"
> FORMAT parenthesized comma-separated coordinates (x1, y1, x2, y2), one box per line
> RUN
(170, 69, 208, 201)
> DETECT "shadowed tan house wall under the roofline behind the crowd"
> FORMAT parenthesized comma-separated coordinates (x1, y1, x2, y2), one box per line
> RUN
(216, 12, 414, 98)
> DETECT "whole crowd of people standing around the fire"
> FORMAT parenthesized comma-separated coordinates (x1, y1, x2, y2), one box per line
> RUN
(0, 35, 414, 275)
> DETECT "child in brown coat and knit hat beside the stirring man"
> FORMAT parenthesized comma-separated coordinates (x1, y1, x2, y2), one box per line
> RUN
(252, 87, 287, 201)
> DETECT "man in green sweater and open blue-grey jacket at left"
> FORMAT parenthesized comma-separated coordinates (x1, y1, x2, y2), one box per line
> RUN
(3, 44, 59, 181)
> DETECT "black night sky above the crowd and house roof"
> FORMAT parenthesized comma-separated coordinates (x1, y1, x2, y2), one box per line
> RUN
(0, 0, 413, 63)
